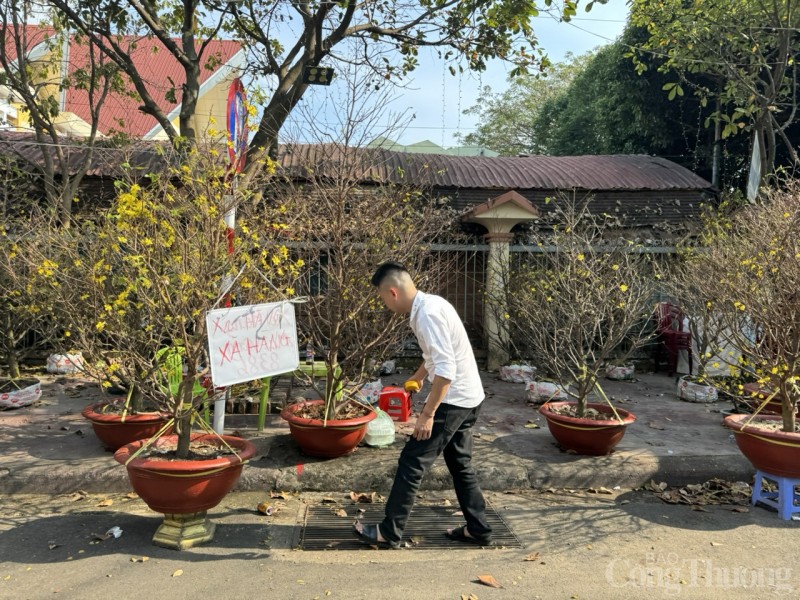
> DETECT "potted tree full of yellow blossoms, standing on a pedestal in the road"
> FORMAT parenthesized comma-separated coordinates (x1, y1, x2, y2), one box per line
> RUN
(30, 150, 295, 548)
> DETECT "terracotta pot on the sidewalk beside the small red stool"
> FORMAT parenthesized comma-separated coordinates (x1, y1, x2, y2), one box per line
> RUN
(281, 400, 377, 458)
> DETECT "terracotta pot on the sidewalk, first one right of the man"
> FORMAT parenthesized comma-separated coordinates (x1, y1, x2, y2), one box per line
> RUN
(539, 402, 636, 456)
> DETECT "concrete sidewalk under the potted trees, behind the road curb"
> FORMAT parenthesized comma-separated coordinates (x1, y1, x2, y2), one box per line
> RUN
(0, 373, 755, 494)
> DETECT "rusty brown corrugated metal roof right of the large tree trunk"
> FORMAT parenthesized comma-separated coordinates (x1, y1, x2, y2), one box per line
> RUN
(279, 145, 711, 190)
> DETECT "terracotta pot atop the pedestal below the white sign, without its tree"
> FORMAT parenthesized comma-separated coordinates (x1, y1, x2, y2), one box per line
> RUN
(114, 433, 256, 515)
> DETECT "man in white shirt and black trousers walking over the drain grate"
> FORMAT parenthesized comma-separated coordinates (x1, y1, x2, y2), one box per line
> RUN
(353, 262, 492, 548)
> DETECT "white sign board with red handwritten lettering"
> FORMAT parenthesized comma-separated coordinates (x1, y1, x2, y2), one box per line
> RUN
(206, 302, 300, 387)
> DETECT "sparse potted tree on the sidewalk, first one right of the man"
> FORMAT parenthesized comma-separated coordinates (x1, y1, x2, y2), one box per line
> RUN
(505, 197, 657, 454)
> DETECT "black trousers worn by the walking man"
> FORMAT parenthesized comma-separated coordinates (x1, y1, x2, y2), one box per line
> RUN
(379, 404, 492, 542)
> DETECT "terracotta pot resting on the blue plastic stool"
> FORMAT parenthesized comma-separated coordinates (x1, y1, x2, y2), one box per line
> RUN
(724, 415, 800, 479)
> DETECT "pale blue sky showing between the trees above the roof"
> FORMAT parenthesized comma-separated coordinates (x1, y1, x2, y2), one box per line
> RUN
(282, 0, 628, 147)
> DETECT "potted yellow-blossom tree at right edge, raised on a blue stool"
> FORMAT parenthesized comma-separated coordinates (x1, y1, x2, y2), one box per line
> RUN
(703, 180, 800, 478)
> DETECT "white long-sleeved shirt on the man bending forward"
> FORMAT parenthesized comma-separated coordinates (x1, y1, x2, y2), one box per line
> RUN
(410, 291, 484, 408)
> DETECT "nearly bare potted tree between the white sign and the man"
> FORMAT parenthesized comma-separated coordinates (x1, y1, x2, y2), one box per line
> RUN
(276, 72, 454, 458)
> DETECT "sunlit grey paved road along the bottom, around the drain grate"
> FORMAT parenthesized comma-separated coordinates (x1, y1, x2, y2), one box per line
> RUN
(0, 489, 800, 600)
